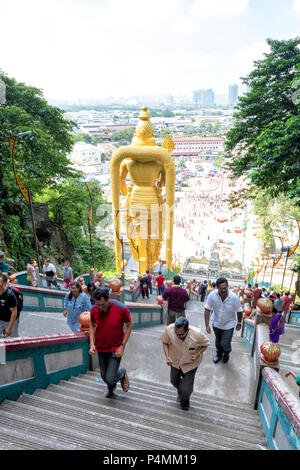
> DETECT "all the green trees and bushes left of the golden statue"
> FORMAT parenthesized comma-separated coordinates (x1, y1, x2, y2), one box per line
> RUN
(0, 76, 113, 274)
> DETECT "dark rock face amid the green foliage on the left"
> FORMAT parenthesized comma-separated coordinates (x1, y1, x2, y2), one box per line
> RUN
(27, 203, 74, 263)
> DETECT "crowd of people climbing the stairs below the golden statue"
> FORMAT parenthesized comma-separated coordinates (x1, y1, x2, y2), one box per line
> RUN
(0, 246, 299, 404)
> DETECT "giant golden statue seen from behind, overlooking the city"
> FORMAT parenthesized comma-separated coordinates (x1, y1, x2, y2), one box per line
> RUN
(110, 107, 176, 274)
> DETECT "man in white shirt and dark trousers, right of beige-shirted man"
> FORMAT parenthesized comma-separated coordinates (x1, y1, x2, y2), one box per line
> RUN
(204, 277, 243, 364)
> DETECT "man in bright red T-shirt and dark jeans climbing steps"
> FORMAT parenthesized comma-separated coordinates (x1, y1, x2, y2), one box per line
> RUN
(89, 287, 133, 398)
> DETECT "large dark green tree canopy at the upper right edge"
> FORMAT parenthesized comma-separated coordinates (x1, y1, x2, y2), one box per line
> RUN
(225, 37, 300, 204)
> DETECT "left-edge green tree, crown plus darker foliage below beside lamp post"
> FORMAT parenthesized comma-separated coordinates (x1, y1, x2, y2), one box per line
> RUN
(0, 76, 79, 269)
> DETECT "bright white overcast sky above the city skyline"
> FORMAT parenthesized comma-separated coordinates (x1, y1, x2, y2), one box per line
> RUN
(0, 0, 300, 100)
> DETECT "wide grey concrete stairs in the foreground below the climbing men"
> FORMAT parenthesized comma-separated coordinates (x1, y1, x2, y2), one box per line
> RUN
(0, 371, 266, 450)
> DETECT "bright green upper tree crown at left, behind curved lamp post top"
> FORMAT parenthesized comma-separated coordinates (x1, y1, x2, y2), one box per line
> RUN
(0, 76, 74, 198)
